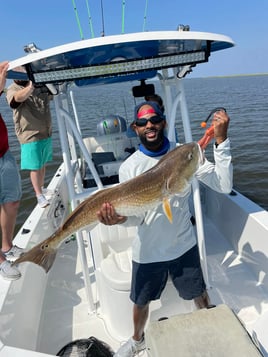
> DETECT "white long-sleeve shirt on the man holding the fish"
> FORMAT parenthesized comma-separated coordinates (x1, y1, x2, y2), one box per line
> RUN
(119, 139, 233, 263)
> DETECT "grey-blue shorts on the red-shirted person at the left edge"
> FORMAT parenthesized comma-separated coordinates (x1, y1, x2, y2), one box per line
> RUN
(0, 151, 21, 205)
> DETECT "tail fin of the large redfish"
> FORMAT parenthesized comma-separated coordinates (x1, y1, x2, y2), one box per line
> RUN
(12, 239, 57, 273)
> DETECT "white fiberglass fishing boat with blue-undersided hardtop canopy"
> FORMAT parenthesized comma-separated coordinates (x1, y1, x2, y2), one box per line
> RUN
(0, 30, 268, 357)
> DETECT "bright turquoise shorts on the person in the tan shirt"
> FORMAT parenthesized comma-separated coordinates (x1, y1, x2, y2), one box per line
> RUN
(21, 137, 52, 170)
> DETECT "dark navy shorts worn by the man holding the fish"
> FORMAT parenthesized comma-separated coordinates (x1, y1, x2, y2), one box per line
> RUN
(130, 245, 206, 306)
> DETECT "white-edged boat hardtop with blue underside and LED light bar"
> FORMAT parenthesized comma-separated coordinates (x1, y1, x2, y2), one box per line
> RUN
(8, 31, 234, 86)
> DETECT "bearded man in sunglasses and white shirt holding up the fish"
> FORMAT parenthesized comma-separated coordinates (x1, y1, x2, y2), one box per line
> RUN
(97, 101, 233, 357)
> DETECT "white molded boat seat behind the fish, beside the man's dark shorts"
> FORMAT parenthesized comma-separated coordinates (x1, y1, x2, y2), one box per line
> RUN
(91, 223, 136, 340)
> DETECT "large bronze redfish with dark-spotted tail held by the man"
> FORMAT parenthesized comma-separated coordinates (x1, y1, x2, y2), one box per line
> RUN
(13, 142, 201, 272)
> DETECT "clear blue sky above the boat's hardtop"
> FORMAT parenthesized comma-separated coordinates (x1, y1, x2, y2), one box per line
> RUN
(0, 0, 268, 77)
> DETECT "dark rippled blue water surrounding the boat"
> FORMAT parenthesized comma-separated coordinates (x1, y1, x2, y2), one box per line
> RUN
(0, 75, 268, 231)
